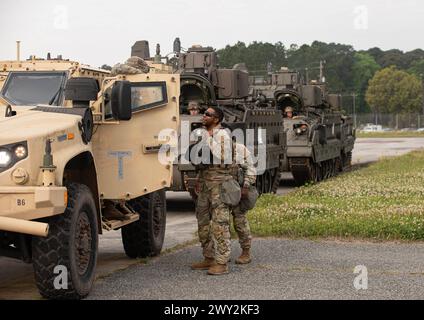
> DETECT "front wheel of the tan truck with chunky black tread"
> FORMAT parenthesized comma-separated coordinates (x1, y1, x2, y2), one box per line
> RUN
(32, 183, 98, 299)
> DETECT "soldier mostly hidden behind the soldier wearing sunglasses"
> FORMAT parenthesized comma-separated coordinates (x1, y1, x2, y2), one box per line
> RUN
(231, 143, 256, 264)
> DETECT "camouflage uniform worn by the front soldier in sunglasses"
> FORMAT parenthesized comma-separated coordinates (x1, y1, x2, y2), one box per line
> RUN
(193, 126, 240, 269)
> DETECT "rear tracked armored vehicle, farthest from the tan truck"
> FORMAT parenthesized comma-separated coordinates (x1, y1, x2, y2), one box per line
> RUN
(250, 68, 355, 185)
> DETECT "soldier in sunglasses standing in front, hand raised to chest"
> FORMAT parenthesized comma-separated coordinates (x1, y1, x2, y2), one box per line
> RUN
(191, 107, 240, 275)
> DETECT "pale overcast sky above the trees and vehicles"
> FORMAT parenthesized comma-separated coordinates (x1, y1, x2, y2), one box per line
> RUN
(0, 0, 424, 66)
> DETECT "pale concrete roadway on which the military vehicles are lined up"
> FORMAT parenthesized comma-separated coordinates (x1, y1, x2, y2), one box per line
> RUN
(0, 138, 424, 299)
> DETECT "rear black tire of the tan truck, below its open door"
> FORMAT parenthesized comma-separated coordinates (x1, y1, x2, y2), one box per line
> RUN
(121, 190, 166, 259)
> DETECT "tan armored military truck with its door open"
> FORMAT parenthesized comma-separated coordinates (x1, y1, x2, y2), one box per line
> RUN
(0, 53, 180, 299)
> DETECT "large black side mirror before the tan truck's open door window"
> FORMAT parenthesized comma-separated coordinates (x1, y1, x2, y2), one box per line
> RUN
(110, 81, 132, 121)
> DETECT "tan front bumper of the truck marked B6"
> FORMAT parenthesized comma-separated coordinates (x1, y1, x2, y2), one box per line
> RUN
(0, 187, 67, 236)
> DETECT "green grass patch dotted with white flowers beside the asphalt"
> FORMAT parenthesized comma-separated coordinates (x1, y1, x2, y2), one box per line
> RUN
(248, 151, 424, 240)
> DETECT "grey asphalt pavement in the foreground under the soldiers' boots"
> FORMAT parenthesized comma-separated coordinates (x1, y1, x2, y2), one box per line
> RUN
(89, 239, 424, 300)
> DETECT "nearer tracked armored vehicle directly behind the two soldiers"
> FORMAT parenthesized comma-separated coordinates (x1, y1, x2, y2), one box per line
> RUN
(132, 38, 286, 198)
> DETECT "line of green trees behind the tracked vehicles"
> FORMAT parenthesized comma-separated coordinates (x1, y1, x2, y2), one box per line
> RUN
(218, 41, 424, 113)
